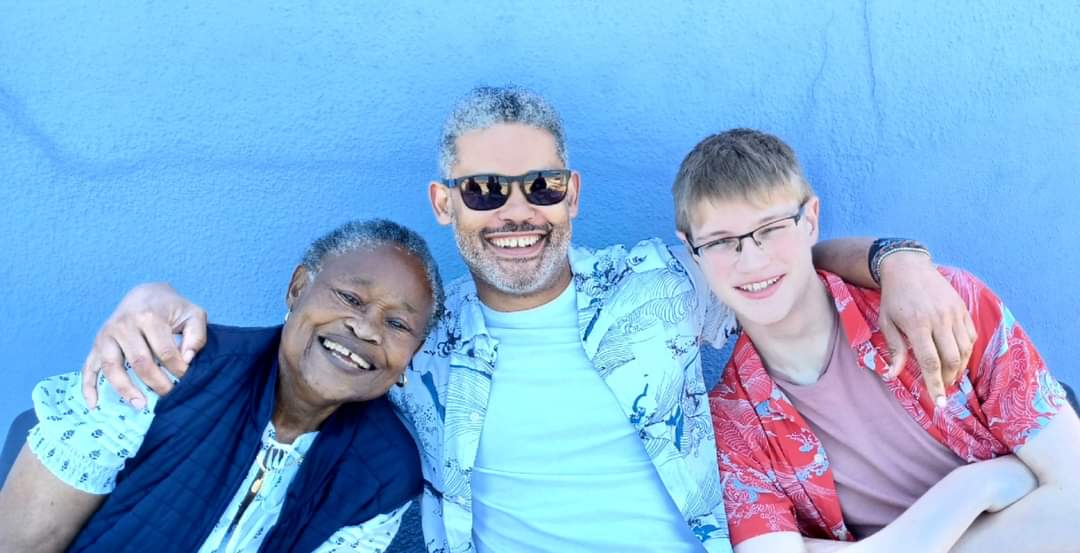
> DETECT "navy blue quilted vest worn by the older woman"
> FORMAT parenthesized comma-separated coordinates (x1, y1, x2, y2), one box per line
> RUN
(69, 325, 421, 553)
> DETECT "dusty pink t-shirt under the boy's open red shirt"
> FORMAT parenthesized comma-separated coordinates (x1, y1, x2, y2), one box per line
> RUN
(774, 328, 964, 539)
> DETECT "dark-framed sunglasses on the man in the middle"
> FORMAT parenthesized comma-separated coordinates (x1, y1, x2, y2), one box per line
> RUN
(443, 168, 571, 212)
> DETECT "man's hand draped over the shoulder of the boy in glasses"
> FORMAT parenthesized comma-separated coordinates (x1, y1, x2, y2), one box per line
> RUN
(880, 252, 977, 406)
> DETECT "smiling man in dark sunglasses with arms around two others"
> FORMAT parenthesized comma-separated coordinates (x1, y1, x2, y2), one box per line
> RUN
(73, 86, 974, 552)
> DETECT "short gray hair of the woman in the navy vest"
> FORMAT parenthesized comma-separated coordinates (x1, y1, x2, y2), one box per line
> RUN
(300, 219, 446, 335)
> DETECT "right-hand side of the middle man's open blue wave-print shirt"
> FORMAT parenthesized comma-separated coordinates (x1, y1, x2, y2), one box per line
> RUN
(571, 240, 731, 551)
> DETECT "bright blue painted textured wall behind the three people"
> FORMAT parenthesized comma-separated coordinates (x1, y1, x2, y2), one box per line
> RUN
(0, 0, 1080, 436)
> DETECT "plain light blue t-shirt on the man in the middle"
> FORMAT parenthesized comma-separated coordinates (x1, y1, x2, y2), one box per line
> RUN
(472, 286, 703, 553)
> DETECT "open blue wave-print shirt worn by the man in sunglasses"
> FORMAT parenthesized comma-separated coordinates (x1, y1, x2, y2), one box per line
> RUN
(390, 240, 735, 553)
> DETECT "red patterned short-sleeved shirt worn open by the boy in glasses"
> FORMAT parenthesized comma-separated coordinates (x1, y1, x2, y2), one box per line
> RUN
(710, 268, 1066, 544)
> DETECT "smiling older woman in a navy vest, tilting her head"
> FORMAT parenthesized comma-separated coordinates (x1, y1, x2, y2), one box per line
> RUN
(0, 220, 443, 553)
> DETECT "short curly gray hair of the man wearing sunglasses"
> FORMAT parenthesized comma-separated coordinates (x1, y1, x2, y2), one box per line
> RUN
(438, 84, 567, 178)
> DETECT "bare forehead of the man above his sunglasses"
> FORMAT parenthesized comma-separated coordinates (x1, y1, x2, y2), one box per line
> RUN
(450, 123, 565, 177)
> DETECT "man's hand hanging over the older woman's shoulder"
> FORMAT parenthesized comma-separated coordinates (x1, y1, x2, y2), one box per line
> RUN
(82, 283, 206, 409)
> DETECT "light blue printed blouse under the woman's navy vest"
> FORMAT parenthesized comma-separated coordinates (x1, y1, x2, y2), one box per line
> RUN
(27, 367, 408, 553)
